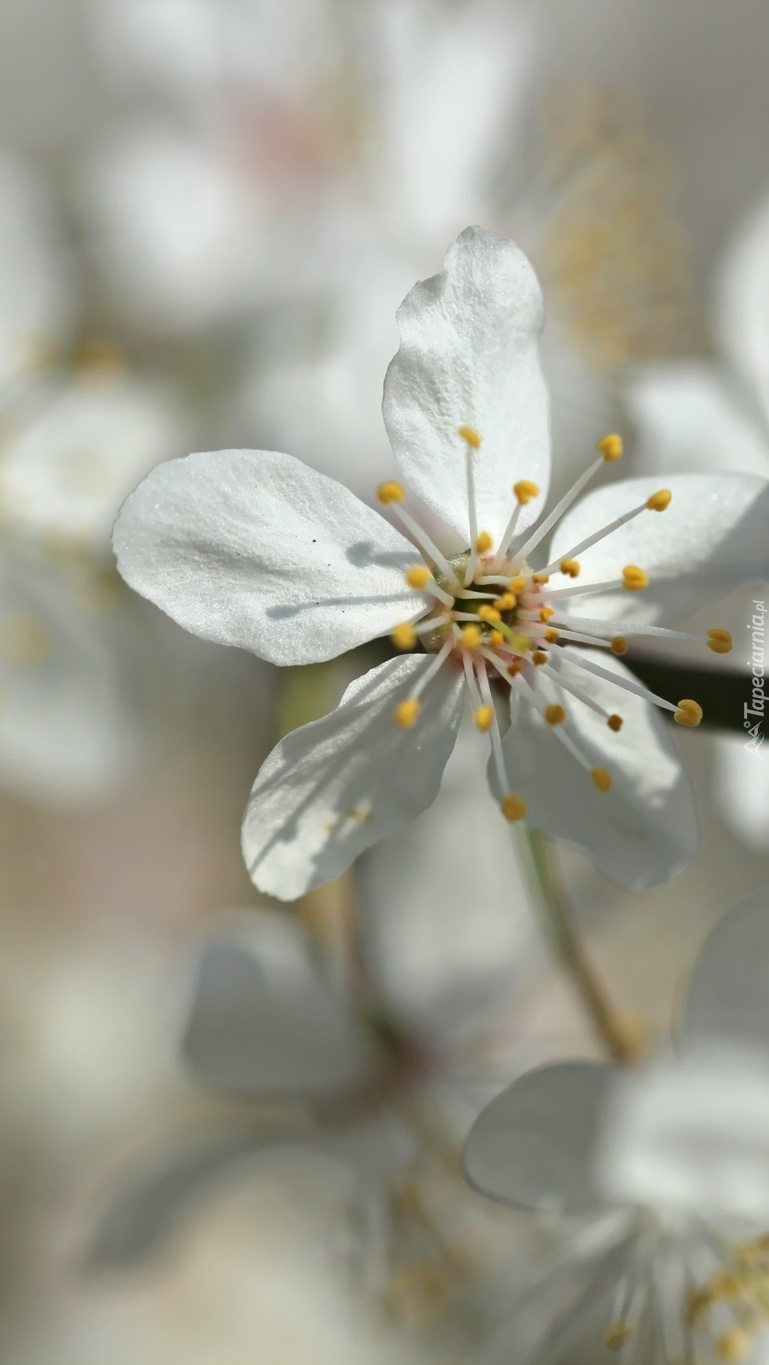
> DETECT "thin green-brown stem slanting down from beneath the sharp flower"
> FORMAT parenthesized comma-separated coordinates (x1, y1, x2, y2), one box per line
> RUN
(526, 829, 639, 1065)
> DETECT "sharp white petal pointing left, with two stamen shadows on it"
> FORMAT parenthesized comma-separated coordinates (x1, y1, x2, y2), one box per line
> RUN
(115, 450, 422, 663)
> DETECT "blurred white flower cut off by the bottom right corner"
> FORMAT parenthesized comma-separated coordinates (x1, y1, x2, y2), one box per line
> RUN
(464, 897, 769, 1365)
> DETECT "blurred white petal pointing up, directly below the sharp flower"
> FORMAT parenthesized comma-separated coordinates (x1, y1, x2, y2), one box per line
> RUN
(359, 728, 537, 1044)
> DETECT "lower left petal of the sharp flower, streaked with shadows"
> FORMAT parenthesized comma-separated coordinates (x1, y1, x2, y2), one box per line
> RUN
(243, 655, 463, 901)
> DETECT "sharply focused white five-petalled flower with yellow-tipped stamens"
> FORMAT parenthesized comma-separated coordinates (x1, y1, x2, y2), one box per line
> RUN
(115, 228, 769, 898)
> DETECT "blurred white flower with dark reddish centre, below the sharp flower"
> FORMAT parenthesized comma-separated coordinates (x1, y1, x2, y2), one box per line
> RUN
(82, 792, 531, 1316)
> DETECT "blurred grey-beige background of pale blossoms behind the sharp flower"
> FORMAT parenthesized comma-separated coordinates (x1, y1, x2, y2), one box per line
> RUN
(0, 0, 769, 1365)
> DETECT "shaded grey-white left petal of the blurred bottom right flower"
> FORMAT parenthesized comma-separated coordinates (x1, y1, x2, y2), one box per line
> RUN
(464, 1062, 613, 1212)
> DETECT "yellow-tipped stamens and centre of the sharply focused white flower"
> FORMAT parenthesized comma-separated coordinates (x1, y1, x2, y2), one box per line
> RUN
(378, 426, 732, 820)
